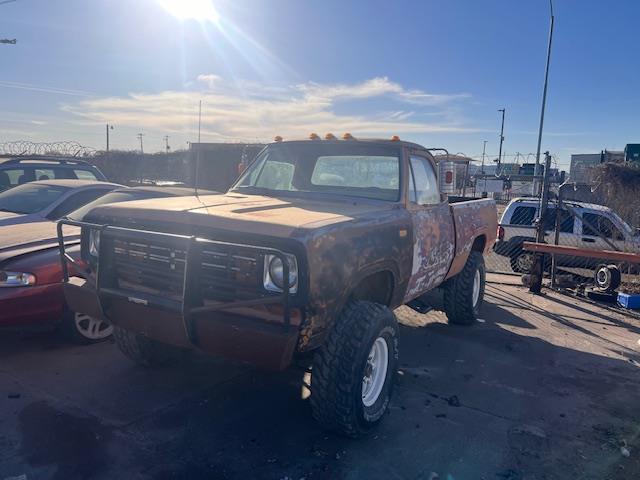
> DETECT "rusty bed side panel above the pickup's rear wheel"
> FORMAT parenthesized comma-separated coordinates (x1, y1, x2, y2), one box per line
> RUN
(447, 199, 498, 278)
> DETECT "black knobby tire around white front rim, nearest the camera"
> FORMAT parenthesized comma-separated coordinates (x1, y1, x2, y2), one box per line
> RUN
(311, 301, 398, 437)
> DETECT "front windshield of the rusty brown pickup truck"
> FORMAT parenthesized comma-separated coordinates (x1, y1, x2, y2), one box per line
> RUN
(232, 141, 400, 202)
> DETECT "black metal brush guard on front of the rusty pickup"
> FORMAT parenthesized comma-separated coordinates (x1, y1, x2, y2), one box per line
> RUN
(57, 219, 291, 347)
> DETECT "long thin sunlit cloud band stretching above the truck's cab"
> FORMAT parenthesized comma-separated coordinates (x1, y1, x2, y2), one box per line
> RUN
(62, 75, 477, 141)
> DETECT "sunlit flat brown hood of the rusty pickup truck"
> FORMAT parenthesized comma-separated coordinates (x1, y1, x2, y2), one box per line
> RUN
(87, 193, 395, 237)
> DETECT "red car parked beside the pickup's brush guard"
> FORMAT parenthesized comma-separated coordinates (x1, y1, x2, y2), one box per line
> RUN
(0, 187, 215, 343)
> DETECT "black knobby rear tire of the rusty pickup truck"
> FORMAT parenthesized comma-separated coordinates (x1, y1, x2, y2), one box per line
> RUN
(444, 252, 486, 325)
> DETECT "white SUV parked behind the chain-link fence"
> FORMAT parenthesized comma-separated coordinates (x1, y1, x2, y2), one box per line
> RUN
(494, 198, 640, 273)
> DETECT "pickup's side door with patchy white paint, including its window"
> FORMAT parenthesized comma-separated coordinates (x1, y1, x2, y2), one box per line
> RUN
(405, 154, 455, 301)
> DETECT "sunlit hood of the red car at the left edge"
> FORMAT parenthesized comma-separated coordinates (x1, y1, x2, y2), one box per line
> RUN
(0, 221, 80, 262)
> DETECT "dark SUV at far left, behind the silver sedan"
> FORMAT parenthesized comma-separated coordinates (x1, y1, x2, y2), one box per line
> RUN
(0, 157, 107, 191)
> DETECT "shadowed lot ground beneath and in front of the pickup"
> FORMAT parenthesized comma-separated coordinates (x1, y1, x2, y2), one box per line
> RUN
(0, 276, 640, 480)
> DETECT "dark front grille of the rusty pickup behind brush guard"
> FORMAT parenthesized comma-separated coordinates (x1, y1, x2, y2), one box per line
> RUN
(111, 238, 265, 301)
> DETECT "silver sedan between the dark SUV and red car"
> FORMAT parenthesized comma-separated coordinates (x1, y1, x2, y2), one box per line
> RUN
(0, 180, 122, 226)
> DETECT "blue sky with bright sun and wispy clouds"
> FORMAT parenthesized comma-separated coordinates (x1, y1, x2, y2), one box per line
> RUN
(0, 0, 640, 168)
